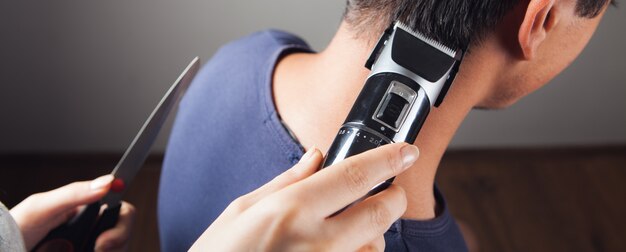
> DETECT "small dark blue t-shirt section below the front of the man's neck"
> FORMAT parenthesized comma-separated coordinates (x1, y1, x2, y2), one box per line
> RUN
(385, 186, 467, 252)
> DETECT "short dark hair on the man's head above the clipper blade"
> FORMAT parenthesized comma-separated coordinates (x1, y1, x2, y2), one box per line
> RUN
(344, 0, 614, 48)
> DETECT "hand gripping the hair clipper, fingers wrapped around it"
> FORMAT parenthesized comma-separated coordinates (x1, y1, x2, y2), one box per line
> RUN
(191, 143, 419, 251)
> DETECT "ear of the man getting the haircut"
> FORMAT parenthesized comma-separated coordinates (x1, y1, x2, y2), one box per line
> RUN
(518, 0, 558, 60)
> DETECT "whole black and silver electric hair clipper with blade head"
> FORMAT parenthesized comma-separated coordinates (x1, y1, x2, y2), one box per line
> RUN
(322, 22, 463, 198)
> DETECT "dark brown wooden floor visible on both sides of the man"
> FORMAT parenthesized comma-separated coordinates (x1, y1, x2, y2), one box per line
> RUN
(0, 146, 626, 251)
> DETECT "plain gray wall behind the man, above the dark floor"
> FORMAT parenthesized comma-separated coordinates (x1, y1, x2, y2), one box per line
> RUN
(0, 0, 626, 153)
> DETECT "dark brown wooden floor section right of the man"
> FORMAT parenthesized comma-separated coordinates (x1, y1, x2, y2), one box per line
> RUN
(438, 147, 626, 251)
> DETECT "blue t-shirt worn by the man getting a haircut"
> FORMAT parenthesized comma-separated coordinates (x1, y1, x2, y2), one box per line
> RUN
(158, 30, 466, 252)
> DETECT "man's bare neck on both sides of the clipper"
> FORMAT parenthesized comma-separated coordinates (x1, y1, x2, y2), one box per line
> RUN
(274, 23, 487, 219)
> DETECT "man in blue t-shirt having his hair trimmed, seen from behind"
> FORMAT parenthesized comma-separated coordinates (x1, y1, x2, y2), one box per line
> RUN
(159, 0, 609, 251)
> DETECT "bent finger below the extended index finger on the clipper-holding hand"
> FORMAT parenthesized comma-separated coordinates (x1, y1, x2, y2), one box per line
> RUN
(325, 185, 407, 251)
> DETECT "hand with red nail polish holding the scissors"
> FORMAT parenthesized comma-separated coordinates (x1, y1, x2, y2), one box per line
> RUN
(11, 175, 135, 251)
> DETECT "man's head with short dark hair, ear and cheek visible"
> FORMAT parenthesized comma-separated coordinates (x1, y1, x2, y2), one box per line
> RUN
(345, 0, 611, 107)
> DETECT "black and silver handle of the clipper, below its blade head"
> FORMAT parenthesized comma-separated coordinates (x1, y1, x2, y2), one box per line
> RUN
(322, 73, 430, 213)
